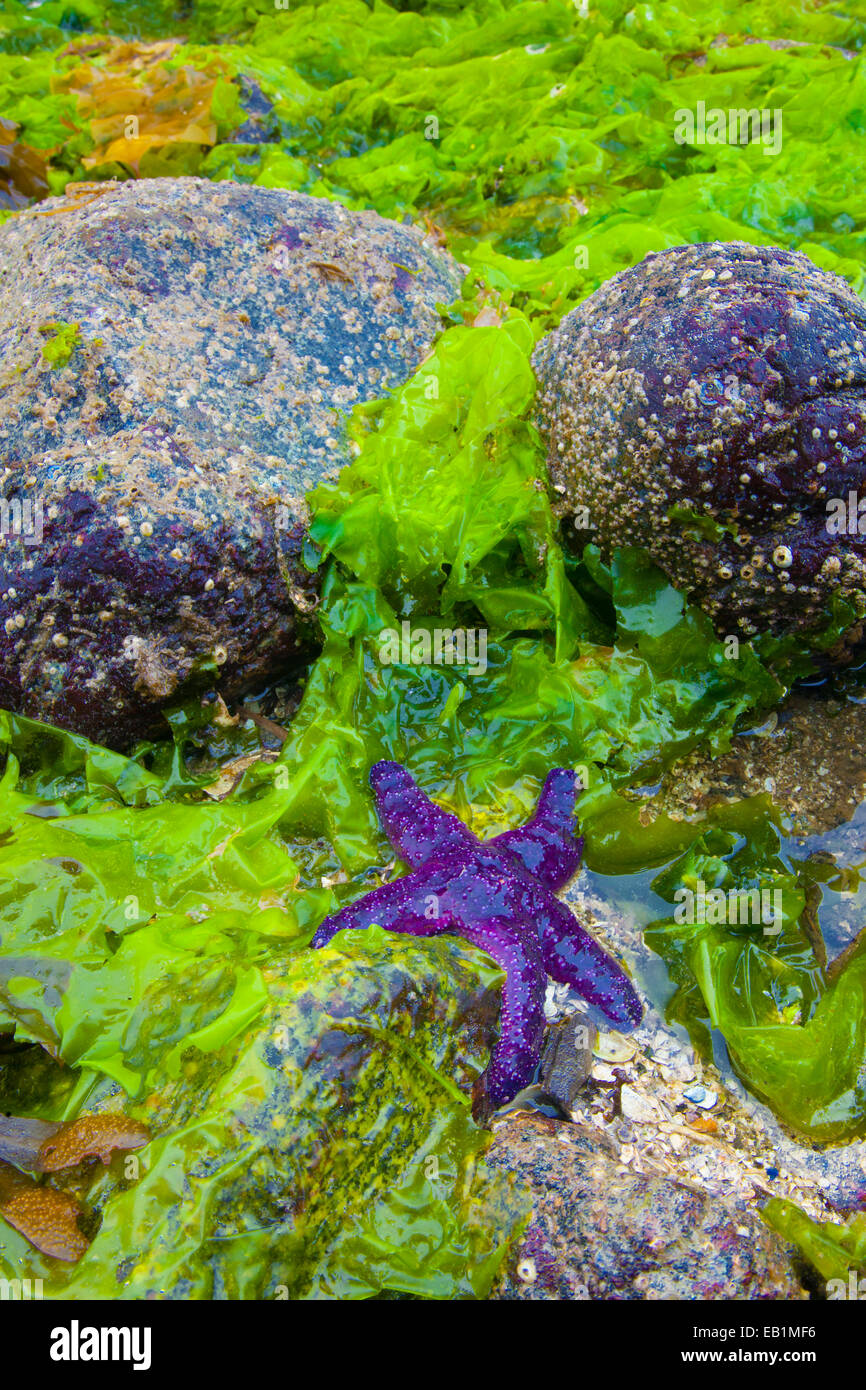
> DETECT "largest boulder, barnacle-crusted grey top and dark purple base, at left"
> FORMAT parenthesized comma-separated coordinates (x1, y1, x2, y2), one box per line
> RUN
(0, 178, 461, 748)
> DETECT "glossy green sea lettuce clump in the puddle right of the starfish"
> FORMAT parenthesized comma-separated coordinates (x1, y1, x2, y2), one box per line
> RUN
(645, 795, 866, 1141)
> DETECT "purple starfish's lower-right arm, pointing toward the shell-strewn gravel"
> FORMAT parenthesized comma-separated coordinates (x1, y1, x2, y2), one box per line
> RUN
(532, 890, 644, 1029)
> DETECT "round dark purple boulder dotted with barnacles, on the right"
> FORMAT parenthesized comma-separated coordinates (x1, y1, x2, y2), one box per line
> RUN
(534, 242, 866, 659)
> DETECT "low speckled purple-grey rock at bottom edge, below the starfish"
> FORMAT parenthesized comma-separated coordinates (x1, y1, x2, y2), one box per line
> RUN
(485, 1115, 805, 1301)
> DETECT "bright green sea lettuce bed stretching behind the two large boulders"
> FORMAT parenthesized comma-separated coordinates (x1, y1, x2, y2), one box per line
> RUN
(0, 0, 866, 312)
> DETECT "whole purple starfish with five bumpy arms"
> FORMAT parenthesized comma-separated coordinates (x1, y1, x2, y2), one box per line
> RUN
(313, 762, 642, 1112)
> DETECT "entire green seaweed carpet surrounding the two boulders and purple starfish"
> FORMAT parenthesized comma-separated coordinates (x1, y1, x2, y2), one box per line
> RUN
(0, 0, 866, 1297)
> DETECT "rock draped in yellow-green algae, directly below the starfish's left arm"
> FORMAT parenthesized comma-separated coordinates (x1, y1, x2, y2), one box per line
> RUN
(0, 934, 514, 1300)
